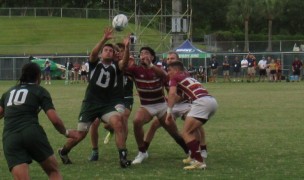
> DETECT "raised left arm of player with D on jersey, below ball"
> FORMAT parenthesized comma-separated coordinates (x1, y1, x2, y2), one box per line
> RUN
(89, 27, 113, 63)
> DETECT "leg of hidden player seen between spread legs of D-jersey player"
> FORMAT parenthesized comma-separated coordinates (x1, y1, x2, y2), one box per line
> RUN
(88, 118, 100, 161)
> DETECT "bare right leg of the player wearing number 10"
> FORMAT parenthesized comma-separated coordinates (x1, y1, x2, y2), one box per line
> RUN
(39, 155, 62, 180)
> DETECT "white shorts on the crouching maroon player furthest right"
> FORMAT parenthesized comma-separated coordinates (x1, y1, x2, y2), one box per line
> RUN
(187, 96, 218, 120)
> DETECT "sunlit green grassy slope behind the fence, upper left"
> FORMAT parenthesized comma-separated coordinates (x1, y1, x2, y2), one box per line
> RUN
(0, 17, 169, 55)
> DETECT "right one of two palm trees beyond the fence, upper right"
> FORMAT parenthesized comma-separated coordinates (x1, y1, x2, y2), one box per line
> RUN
(258, 0, 287, 51)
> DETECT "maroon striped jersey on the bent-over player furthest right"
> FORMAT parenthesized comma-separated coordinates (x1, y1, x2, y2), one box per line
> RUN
(169, 72, 210, 101)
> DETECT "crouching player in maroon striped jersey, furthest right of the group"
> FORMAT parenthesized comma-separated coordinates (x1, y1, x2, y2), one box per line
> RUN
(166, 61, 218, 170)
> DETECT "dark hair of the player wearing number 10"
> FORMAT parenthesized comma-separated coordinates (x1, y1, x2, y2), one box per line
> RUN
(19, 62, 41, 84)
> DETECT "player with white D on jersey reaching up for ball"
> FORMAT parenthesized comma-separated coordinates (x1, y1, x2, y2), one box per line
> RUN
(58, 28, 130, 168)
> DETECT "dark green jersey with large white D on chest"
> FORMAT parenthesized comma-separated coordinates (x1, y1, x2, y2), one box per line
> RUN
(84, 61, 123, 104)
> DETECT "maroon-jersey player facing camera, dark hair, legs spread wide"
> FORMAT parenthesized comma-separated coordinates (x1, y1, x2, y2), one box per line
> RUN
(126, 47, 188, 164)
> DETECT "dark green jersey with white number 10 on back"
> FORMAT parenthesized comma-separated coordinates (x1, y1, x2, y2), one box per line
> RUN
(0, 84, 54, 137)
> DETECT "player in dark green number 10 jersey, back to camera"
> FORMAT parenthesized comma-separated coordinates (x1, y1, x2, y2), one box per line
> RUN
(0, 63, 79, 180)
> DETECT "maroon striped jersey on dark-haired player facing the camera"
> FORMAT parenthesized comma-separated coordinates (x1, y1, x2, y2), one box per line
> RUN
(126, 65, 165, 105)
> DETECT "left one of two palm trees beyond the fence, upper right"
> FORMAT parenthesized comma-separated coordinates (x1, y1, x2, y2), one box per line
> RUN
(227, 0, 256, 52)
